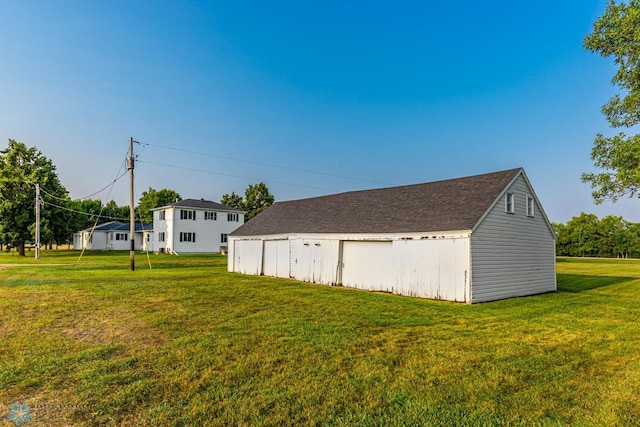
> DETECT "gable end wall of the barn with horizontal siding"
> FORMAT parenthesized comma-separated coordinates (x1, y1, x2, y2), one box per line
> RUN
(471, 175, 556, 302)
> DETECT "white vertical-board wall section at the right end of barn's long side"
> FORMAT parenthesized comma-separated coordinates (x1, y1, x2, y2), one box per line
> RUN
(393, 237, 469, 302)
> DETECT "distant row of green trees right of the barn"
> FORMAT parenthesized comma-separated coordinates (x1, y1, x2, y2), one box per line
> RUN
(552, 212, 640, 258)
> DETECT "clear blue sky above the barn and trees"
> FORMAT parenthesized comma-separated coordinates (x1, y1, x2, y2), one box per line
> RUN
(0, 0, 640, 222)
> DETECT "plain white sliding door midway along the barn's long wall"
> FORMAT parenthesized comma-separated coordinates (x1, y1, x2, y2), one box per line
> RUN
(342, 241, 394, 292)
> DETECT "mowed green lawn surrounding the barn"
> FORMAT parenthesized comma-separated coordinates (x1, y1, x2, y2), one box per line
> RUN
(0, 251, 640, 426)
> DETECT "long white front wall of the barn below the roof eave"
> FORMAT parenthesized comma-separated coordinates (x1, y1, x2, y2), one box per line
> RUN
(228, 232, 469, 302)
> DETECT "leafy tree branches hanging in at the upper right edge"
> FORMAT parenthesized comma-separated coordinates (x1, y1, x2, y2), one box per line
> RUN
(582, 0, 640, 203)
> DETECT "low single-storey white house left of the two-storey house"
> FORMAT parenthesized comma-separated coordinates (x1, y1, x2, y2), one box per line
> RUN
(73, 221, 152, 251)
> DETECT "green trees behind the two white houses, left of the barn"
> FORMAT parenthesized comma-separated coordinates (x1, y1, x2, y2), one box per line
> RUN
(0, 139, 274, 255)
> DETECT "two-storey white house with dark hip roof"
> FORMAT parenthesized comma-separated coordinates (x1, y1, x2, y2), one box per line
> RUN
(152, 199, 244, 254)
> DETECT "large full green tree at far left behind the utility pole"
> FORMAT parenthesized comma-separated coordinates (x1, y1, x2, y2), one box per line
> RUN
(0, 139, 69, 256)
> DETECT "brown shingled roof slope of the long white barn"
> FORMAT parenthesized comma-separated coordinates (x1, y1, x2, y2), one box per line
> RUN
(230, 168, 522, 236)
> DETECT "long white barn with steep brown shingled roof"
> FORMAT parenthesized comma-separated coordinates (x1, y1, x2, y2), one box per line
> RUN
(228, 168, 556, 303)
